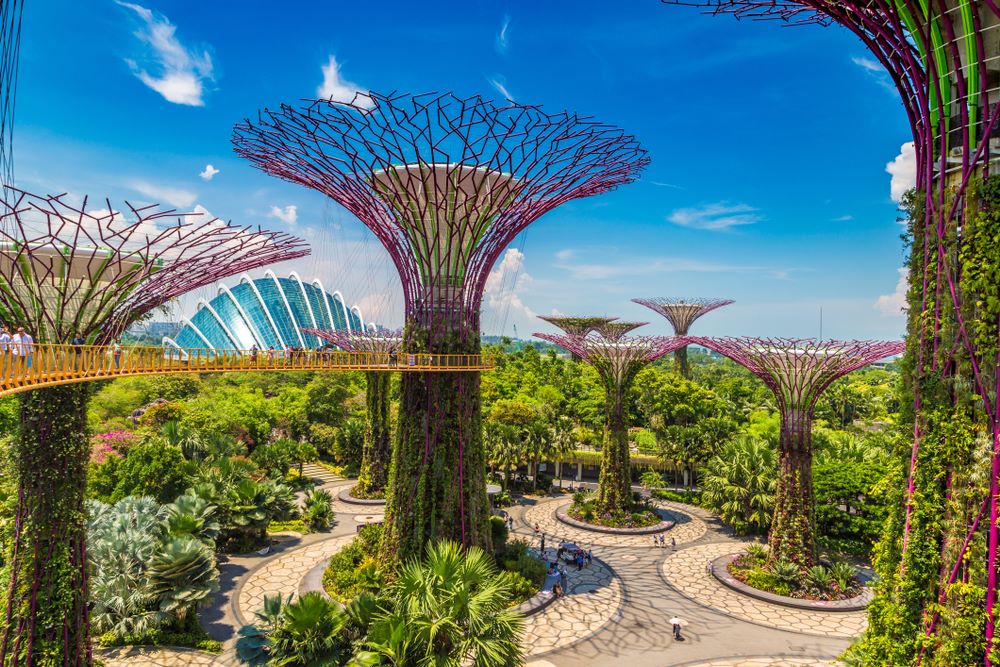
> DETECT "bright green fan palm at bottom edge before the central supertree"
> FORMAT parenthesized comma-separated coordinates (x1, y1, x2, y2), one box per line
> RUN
(362, 541, 524, 667)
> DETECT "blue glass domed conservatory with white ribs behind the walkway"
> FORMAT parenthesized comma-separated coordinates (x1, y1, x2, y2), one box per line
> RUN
(163, 271, 374, 350)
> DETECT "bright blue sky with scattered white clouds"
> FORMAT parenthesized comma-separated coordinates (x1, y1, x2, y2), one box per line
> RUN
(14, 0, 910, 338)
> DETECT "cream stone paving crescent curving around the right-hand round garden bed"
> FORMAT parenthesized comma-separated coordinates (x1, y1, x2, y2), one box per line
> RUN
(662, 542, 867, 638)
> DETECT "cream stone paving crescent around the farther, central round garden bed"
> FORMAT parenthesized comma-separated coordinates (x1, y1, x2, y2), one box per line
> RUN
(523, 498, 708, 548)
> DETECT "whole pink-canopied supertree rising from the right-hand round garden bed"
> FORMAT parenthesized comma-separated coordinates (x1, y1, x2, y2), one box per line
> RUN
(688, 337, 906, 566)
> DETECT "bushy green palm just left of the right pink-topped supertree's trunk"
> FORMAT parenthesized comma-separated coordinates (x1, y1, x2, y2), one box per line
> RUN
(702, 435, 778, 532)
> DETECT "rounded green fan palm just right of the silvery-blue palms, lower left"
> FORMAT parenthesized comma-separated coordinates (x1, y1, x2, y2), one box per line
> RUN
(146, 537, 219, 622)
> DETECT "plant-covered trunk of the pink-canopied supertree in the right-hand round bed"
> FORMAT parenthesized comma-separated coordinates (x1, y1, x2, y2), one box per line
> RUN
(768, 409, 816, 567)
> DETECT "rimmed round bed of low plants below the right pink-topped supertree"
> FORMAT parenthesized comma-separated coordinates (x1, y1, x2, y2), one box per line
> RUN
(712, 544, 870, 611)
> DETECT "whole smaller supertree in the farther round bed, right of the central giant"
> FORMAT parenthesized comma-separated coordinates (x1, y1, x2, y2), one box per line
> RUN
(535, 332, 685, 514)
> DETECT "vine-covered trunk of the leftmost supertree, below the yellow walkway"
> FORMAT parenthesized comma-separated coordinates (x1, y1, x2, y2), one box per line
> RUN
(0, 383, 93, 667)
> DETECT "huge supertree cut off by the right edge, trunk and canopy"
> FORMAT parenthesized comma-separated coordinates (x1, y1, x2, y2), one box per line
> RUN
(664, 0, 1000, 667)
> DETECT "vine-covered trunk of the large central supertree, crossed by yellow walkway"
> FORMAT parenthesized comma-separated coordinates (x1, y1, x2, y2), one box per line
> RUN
(382, 316, 491, 561)
